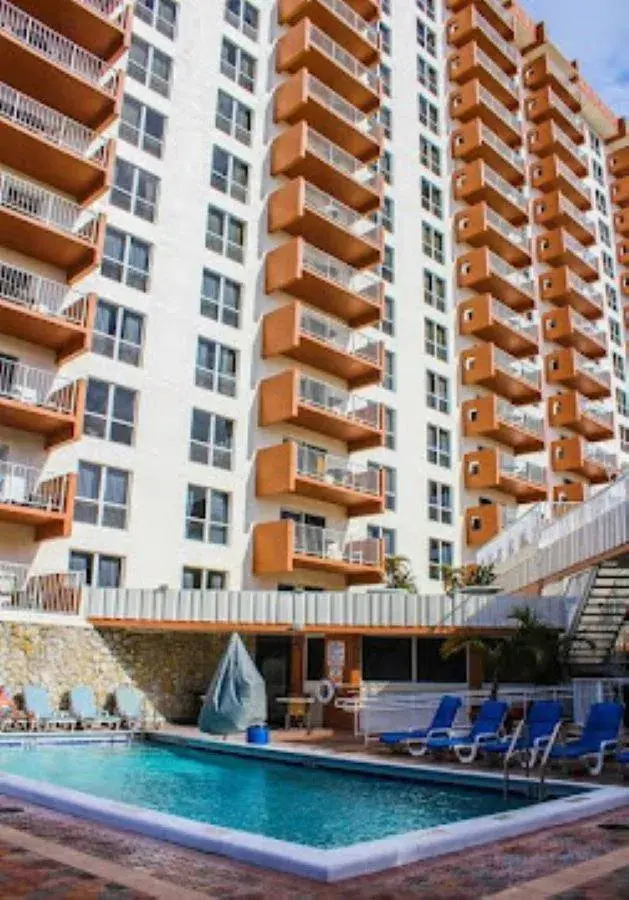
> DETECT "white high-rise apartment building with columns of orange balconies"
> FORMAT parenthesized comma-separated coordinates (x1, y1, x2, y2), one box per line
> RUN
(0, 0, 629, 593)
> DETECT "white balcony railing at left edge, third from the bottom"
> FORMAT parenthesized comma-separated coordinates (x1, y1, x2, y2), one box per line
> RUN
(0, 357, 78, 414)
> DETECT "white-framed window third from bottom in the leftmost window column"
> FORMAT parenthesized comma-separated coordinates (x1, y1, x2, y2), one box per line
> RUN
(83, 378, 137, 446)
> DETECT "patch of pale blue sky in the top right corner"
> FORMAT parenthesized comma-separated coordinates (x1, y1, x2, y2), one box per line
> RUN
(520, 0, 629, 116)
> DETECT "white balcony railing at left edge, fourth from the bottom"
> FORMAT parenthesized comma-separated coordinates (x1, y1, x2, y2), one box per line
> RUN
(0, 263, 88, 325)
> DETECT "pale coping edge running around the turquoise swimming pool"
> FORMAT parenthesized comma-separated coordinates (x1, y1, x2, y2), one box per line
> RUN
(0, 734, 629, 882)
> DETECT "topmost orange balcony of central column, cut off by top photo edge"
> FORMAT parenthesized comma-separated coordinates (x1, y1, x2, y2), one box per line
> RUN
(278, 0, 380, 66)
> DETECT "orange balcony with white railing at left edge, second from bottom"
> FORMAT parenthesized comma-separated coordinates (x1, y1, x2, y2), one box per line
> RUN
(0, 462, 76, 541)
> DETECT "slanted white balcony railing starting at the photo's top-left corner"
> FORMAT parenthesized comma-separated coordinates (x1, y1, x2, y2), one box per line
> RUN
(0, 0, 116, 97)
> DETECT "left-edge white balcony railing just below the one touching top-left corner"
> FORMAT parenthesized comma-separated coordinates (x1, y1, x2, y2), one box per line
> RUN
(0, 82, 107, 165)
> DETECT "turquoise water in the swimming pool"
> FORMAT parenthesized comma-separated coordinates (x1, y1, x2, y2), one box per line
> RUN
(0, 743, 540, 848)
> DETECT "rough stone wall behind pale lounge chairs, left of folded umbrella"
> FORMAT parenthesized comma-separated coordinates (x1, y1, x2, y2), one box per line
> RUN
(0, 621, 245, 721)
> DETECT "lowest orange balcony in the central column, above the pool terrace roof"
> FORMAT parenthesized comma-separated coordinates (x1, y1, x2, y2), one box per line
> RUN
(253, 519, 384, 586)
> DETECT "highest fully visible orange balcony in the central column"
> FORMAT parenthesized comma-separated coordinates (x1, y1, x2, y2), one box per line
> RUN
(275, 19, 380, 112)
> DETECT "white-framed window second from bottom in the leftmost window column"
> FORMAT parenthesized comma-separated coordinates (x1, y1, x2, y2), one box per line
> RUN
(74, 462, 129, 528)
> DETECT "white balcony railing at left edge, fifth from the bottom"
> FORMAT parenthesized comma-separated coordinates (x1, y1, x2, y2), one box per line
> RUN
(0, 171, 98, 243)
